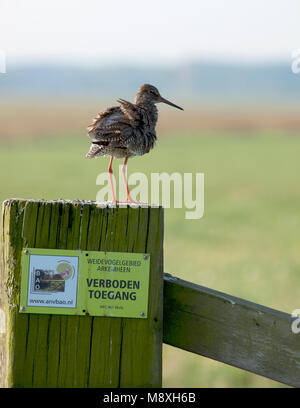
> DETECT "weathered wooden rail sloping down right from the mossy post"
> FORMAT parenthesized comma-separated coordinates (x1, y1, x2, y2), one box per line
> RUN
(163, 274, 300, 387)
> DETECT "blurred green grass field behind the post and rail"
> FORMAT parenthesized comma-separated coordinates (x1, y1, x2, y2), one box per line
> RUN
(0, 132, 300, 387)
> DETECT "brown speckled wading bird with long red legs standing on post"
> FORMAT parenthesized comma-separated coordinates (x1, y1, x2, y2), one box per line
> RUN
(86, 84, 183, 203)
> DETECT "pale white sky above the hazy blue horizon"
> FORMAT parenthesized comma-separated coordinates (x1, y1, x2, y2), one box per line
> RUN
(0, 0, 300, 65)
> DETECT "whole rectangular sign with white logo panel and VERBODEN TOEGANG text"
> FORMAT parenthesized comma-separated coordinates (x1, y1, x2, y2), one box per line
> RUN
(20, 248, 150, 318)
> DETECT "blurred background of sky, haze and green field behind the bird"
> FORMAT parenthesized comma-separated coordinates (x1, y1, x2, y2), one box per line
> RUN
(0, 0, 300, 387)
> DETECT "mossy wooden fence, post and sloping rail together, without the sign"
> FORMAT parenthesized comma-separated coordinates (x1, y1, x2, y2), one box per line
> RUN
(0, 199, 300, 387)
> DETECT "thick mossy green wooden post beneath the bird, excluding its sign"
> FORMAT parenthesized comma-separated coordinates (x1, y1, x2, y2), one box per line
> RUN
(0, 199, 163, 387)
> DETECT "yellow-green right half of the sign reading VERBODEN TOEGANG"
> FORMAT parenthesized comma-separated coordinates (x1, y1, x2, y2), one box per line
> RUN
(81, 252, 150, 317)
